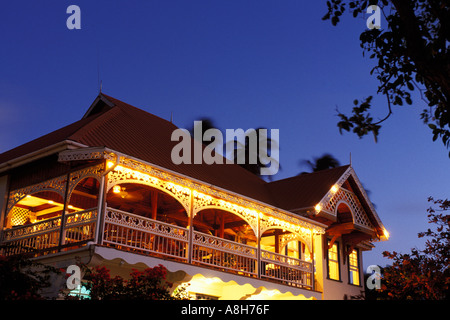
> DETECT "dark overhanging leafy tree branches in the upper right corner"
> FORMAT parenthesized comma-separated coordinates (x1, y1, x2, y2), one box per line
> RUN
(323, 0, 450, 156)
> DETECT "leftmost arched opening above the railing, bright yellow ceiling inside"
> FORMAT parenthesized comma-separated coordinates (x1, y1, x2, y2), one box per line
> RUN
(6, 191, 64, 228)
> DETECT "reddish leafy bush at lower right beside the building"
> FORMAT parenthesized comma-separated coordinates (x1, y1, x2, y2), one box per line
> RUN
(380, 197, 450, 300)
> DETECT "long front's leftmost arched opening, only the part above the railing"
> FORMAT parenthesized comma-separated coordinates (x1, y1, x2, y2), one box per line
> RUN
(106, 183, 189, 227)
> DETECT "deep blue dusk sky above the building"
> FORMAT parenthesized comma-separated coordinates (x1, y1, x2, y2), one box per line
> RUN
(0, 0, 450, 266)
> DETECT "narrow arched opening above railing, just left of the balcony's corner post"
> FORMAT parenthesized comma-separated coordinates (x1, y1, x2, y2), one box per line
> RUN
(67, 177, 100, 213)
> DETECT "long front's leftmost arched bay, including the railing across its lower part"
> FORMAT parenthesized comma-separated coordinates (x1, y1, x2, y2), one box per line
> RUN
(102, 183, 189, 261)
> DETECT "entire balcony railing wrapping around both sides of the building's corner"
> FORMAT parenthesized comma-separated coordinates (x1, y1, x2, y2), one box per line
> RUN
(1, 208, 313, 289)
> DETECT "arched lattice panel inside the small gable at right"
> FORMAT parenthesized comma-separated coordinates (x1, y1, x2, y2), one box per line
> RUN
(324, 188, 373, 229)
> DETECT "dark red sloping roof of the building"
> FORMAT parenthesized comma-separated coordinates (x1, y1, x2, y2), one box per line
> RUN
(0, 93, 386, 238)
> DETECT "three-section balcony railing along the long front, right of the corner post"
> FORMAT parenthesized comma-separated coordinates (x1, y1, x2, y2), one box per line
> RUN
(102, 208, 313, 289)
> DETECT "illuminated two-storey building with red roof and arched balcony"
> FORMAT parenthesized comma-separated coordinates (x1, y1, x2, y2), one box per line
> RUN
(0, 94, 388, 299)
